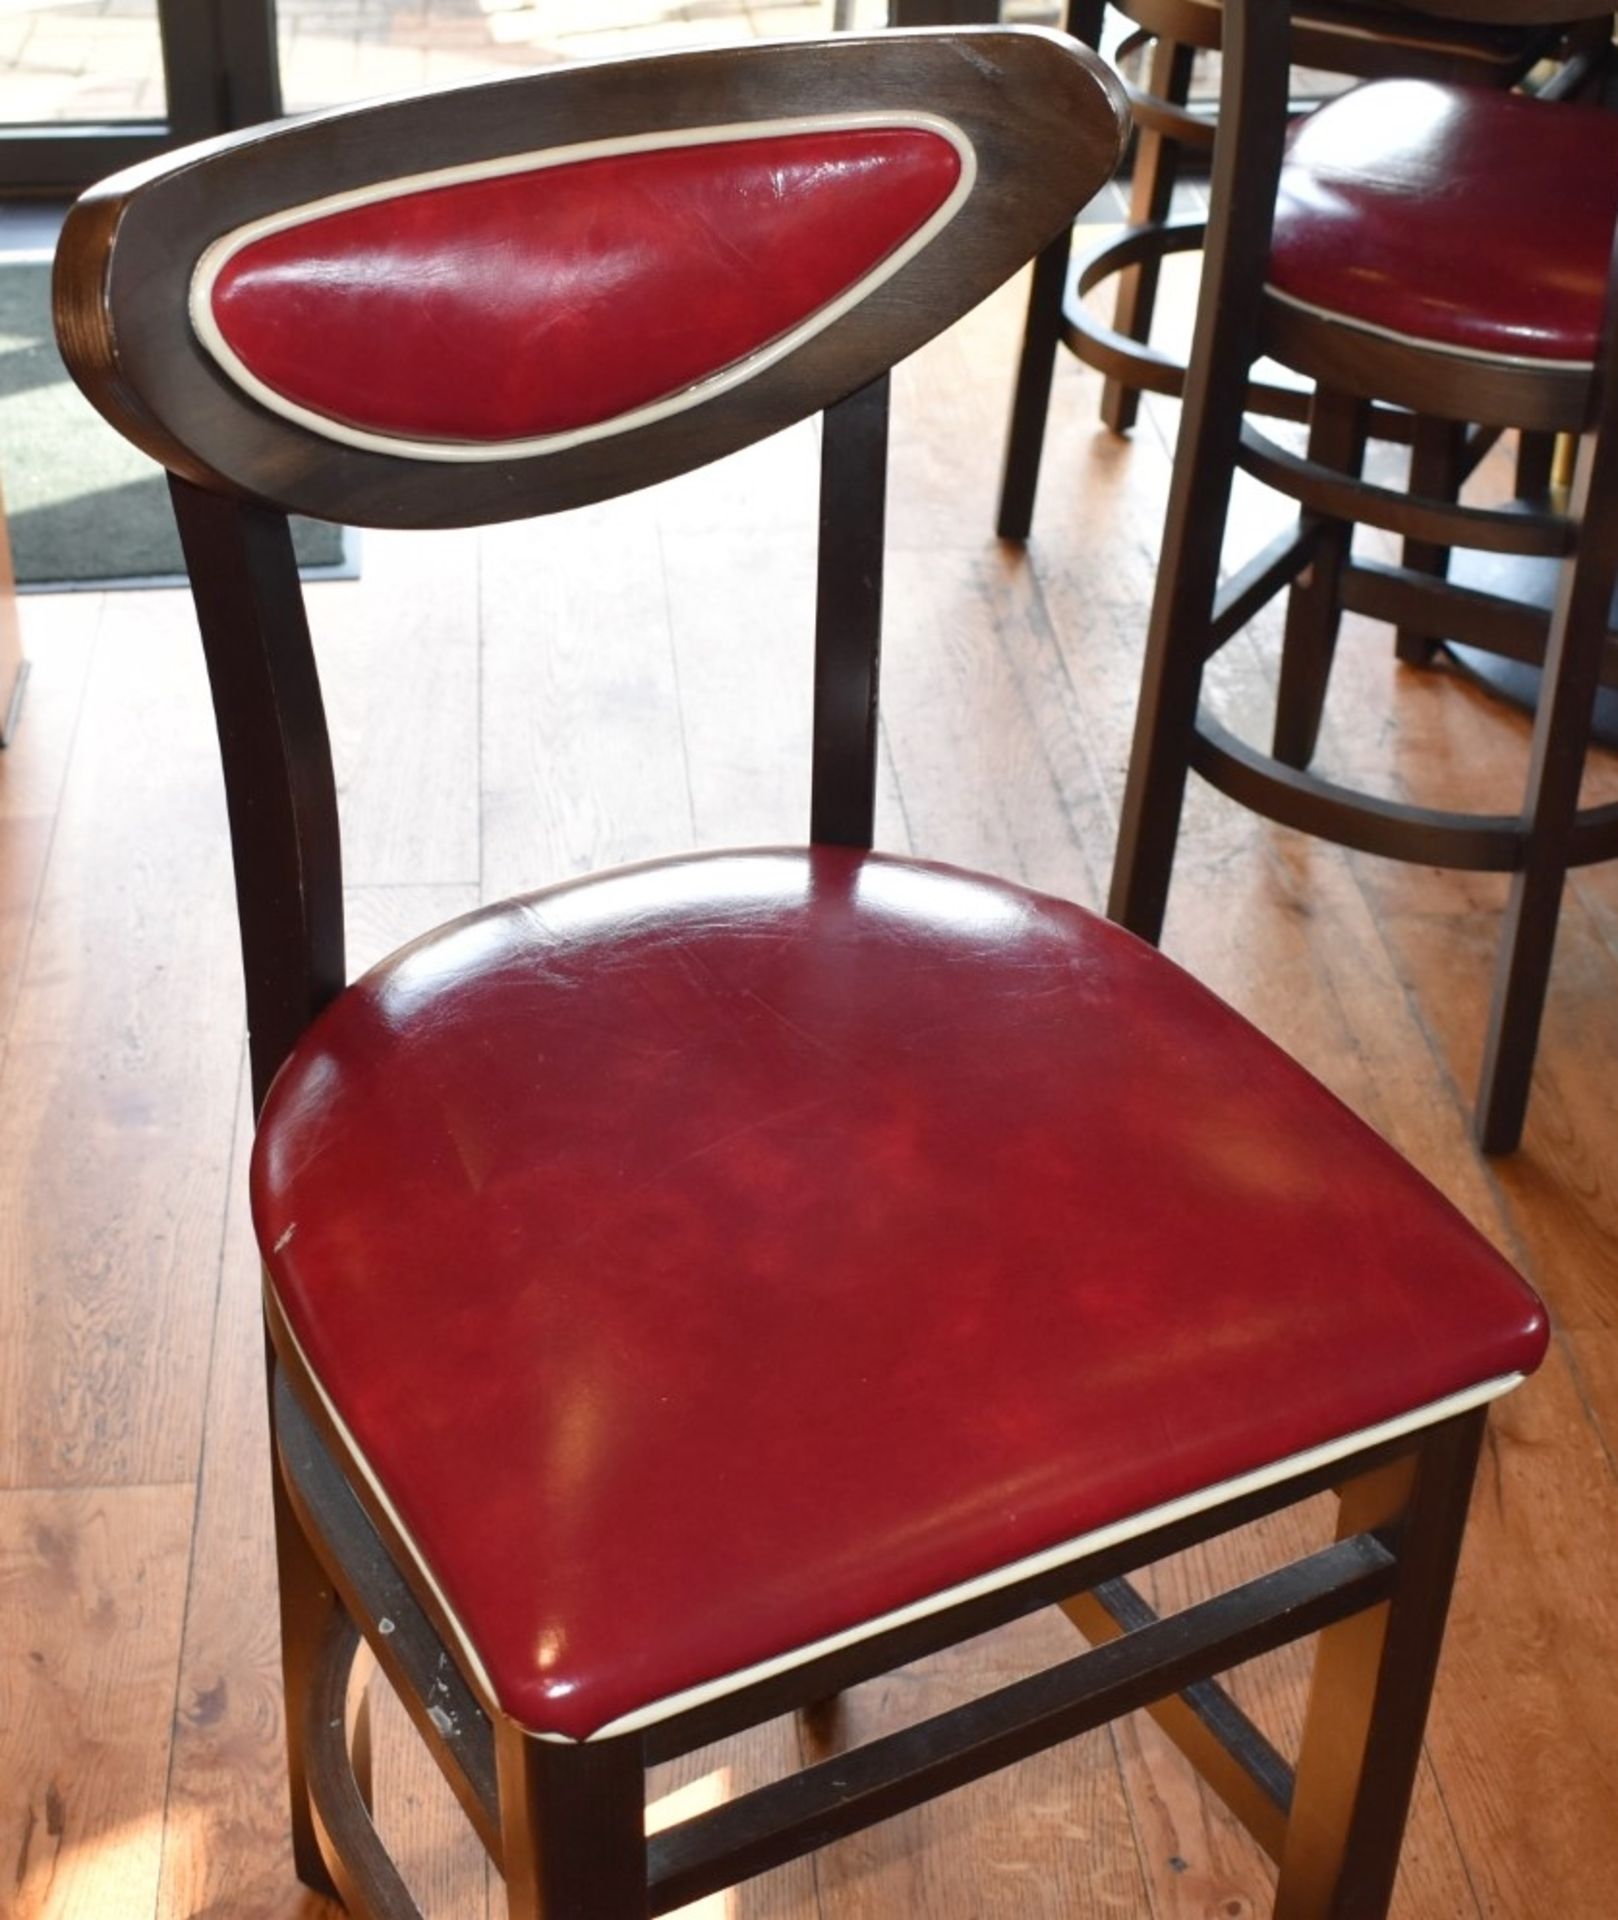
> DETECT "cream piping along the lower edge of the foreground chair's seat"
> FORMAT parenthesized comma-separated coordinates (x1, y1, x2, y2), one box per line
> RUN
(265, 1279, 1526, 1747)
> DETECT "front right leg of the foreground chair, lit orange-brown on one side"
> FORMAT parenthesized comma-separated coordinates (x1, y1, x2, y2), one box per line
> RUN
(1274, 1411, 1484, 1920)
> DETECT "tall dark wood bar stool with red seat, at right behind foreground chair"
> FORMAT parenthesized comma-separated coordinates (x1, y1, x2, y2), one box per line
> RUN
(1109, 0, 1618, 1152)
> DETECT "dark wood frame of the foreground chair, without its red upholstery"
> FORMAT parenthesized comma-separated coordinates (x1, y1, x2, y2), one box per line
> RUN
(58, 22, 1484, 1920)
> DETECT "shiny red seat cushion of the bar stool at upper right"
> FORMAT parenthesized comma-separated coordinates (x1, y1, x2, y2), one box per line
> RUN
(1269, 81, 1618, 363)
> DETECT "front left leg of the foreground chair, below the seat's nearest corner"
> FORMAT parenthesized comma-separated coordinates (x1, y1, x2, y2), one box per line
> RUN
(495, 1720, 649, 1920)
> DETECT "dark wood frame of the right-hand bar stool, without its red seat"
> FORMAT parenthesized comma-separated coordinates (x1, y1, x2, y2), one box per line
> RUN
(1109, 0, 1618, 1152)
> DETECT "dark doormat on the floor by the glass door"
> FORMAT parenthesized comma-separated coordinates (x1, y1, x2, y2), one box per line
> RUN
(0, 259, 359, 588)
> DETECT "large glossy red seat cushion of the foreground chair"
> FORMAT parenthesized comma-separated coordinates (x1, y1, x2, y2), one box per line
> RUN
(253, 849, 1545, 1738)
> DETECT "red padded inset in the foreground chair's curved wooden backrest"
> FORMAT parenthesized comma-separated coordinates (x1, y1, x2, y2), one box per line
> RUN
(211, 127, 962, 444)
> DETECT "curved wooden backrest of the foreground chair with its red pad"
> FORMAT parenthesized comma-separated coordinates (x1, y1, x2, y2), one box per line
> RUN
(56, 29, 1127, 526)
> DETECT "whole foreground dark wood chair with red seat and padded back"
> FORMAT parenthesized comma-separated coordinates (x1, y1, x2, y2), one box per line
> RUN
(58, 29, 1545, 1920)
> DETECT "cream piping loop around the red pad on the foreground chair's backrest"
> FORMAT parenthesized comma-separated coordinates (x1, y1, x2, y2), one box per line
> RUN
(188, 111, 977, 463)
